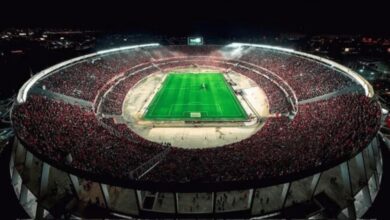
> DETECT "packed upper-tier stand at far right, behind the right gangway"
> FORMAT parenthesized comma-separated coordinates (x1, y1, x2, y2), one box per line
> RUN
(240, 48, 356, 100)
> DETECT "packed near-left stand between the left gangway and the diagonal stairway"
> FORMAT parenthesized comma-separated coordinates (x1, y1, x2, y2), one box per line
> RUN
(12, 96, 163, 178)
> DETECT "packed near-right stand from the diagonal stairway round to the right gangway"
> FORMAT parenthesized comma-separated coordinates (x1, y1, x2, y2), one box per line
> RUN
(144, 95, 380, 182)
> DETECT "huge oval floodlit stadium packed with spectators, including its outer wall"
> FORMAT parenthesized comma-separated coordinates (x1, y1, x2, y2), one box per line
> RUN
(10, 39, 384, 219)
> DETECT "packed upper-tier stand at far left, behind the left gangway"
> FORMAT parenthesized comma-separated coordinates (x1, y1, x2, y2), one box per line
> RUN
(39, 51, 150, 102)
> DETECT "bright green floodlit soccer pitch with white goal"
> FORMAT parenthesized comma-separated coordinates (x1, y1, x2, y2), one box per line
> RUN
(144, 73, 247, 121)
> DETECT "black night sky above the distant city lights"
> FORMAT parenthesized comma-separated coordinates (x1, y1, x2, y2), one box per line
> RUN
(0, 0, 390, 35)
